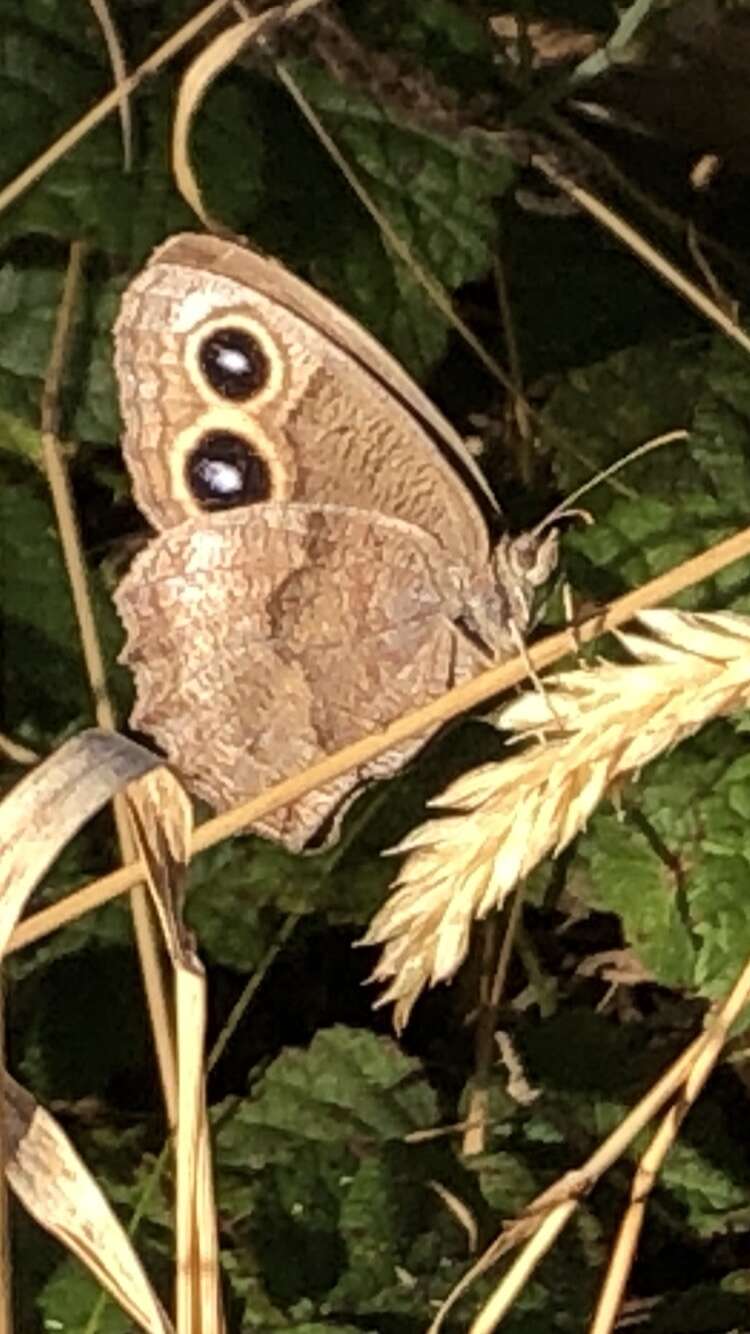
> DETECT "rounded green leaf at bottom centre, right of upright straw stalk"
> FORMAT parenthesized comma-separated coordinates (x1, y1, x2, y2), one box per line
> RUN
(216, 1027, 472, 1329)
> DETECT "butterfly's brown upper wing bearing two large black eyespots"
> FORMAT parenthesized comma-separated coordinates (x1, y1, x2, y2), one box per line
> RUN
(116, 236, 488, 568)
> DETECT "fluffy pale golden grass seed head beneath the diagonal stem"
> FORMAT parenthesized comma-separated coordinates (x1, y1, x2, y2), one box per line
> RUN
(366, 611, 750, 1029)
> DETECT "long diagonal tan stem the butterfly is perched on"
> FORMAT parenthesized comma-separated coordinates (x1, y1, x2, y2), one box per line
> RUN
(9, 528, 750, 950)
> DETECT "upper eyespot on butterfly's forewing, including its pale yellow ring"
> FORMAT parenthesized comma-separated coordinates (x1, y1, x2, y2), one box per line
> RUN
(185, 309, 287, 412)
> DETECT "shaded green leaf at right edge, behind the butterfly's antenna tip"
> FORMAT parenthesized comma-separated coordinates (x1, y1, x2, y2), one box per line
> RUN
(542, 339, 750, 611)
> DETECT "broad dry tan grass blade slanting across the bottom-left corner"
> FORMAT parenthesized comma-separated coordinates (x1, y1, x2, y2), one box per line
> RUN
(4, 1074, 172, 1334)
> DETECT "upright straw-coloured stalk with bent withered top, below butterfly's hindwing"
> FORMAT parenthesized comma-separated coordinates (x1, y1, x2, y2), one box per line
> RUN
(122, 768, 223, 1334)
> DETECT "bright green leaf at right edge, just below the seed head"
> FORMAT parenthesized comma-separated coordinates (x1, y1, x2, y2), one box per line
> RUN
(577, 723, 750, 999)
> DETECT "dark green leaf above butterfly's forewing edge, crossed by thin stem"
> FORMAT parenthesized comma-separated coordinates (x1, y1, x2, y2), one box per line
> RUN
(277, 64, 514, 375)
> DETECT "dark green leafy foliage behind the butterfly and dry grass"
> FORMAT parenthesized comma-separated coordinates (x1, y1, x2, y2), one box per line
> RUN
(0, 0, 750, 1334)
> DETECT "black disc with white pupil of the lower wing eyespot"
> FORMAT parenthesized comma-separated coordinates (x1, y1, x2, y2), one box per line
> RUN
(185, 431, 272, 510)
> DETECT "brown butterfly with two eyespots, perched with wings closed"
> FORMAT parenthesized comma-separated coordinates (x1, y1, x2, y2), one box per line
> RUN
(115, 236, 551, 848)
